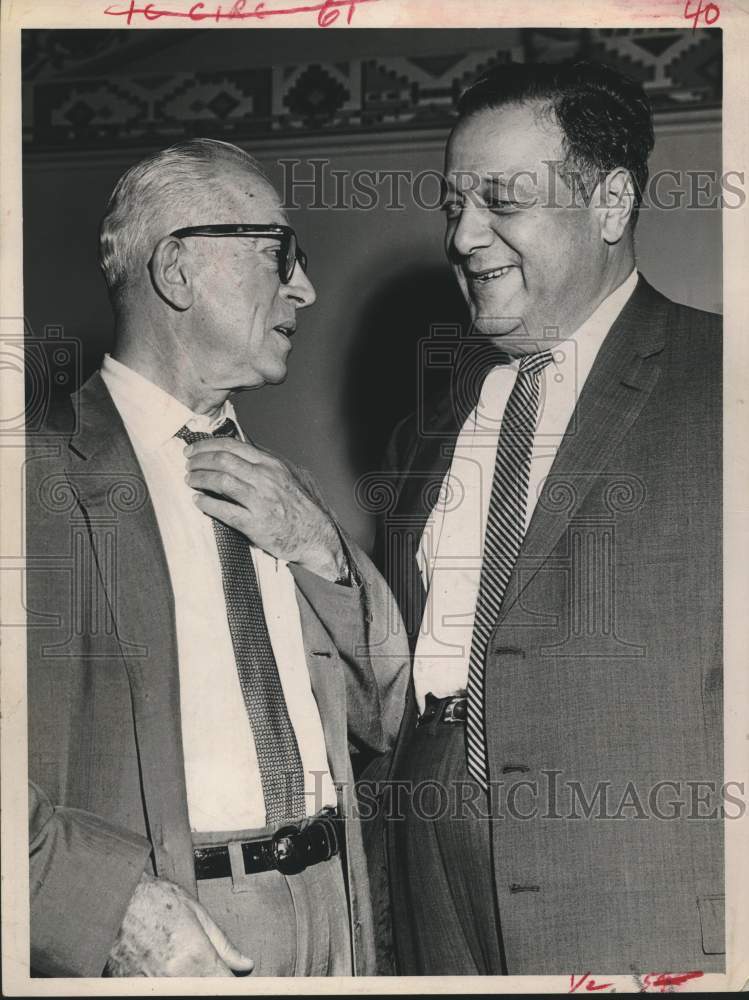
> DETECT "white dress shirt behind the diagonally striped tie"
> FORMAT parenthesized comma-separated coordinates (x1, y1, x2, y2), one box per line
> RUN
(413, 270, 637, 712)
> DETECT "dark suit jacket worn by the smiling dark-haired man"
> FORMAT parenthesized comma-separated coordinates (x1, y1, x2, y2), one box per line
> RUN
(373, 277, 724, 974)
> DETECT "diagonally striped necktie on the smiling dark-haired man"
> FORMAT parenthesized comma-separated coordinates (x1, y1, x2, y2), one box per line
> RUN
(466, 351, 552, 791)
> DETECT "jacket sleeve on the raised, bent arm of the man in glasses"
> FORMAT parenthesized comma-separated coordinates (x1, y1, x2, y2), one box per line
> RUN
(289, 470, 409, 753)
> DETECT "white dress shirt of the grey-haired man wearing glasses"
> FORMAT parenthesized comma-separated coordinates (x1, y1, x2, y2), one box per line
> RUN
(101, 355, 336, 832)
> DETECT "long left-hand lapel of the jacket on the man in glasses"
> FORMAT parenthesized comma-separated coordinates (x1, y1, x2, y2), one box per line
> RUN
(68, 373, 194, 888)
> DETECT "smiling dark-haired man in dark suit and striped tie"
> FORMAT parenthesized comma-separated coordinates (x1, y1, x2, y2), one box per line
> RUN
(373, 63, 725, 975)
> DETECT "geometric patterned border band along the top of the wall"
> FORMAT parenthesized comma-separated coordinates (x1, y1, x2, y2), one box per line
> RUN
(22, 28, 722, 151)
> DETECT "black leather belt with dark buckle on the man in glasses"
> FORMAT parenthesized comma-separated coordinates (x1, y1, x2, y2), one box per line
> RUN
(193, 809, 343, 879)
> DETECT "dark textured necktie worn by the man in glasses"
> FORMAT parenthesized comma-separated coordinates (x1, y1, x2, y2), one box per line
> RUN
(176, 420, 307, 825)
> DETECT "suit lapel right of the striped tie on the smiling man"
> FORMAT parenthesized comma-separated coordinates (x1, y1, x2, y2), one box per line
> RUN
(499, 277, 668, 622)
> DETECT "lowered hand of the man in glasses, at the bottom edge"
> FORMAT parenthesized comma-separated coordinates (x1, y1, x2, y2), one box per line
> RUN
(105, 872, 255, 976)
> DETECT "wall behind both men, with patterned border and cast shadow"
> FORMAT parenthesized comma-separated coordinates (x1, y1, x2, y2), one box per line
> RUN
(24, 29, 722, 545)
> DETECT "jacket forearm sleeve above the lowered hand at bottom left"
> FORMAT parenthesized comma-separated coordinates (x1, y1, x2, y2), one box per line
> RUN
(29, 782, 150, 976)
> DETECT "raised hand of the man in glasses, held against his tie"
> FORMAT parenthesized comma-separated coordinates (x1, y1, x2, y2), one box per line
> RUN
(185, 438, 347, 580)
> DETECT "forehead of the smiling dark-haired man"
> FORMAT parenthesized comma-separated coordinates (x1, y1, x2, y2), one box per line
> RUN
(445, 101, 564, 189)
